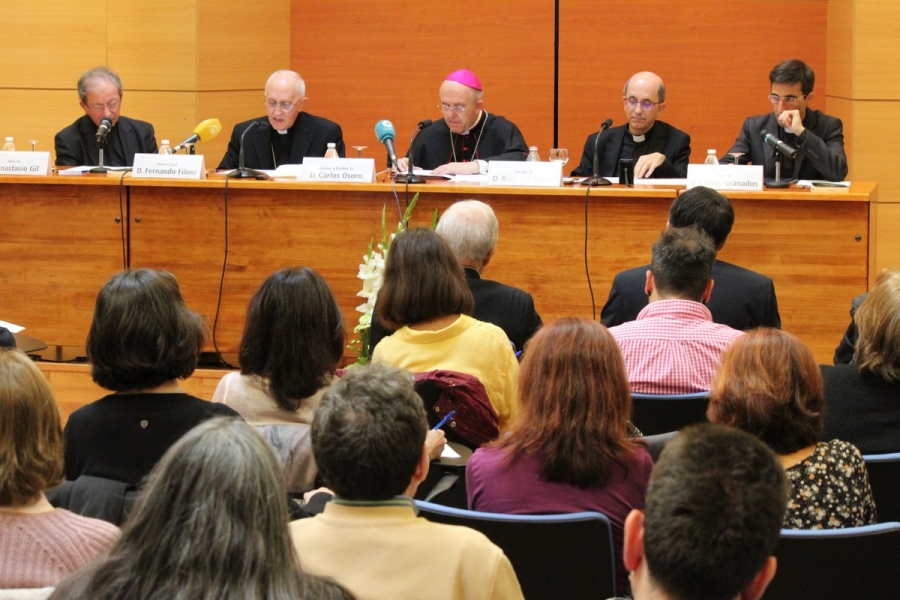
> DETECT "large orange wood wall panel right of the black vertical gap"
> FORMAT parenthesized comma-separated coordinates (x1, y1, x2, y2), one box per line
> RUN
(559, 0, 827, 169)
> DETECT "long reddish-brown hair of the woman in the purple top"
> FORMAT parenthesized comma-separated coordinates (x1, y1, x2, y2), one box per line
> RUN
(497, 317, 638, 488)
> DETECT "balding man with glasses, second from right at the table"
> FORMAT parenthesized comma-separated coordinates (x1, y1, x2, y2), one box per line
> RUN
(572, 72, 691, 178)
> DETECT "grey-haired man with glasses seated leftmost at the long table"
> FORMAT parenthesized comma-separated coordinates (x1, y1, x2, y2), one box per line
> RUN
(54, 67, 157, 167)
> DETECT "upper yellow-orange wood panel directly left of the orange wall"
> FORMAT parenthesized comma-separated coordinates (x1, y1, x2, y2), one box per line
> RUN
(196, 0, 288, 90)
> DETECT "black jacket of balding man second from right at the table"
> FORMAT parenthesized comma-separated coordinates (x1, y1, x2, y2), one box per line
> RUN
(572, 121, 691, 178)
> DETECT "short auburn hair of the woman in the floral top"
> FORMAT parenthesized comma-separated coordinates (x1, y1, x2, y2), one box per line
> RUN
(708, 327, 825, 454)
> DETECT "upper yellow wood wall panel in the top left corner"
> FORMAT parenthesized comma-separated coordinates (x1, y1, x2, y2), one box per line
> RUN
(0, 0, 107, 88)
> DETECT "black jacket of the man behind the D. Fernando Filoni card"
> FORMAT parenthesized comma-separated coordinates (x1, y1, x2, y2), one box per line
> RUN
(219, 112, 344, 169)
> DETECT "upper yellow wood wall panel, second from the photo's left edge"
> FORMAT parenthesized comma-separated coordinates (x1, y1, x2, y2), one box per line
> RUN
(106, 0, 198, 91)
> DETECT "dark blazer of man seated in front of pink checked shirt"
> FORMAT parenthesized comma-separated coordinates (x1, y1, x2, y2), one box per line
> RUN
(600, 260, 781, 331)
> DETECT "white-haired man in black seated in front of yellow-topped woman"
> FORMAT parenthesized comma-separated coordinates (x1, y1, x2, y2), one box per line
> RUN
(369, 200, 543, 350)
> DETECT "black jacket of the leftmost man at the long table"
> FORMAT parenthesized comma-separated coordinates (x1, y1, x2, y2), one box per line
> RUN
(53, 115, 159, 167)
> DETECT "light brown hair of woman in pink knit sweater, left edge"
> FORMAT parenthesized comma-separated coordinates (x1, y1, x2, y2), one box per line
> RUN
(0, 348, 63, 506)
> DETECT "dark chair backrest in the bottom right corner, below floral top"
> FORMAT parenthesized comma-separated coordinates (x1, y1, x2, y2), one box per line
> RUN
(764, 523, 900, 600)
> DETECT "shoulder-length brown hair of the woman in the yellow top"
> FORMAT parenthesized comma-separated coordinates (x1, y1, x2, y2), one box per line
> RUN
(377, 228, 475, 329)
